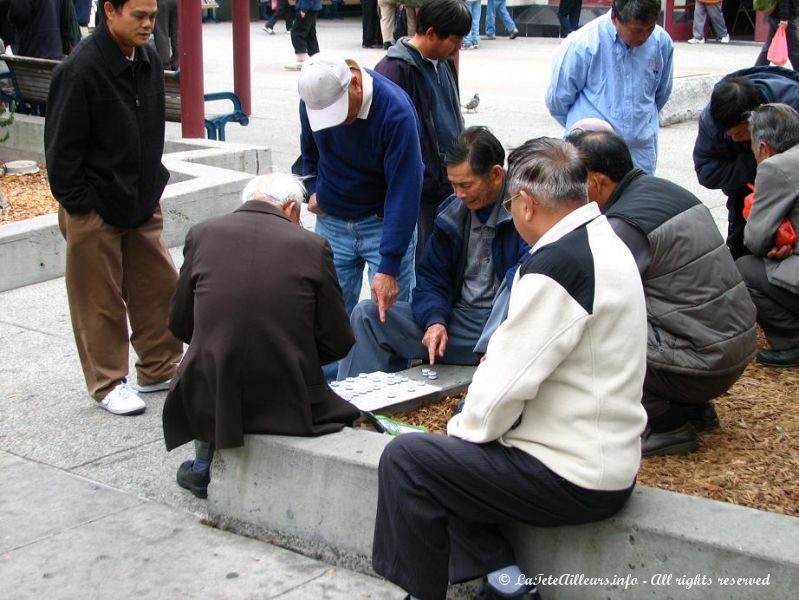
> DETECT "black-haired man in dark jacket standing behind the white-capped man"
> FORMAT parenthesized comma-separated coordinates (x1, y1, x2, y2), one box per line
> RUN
(375, 0, 472, 258)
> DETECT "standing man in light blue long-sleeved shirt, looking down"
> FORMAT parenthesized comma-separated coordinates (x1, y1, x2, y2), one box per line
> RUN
(546, 0, 674, 174)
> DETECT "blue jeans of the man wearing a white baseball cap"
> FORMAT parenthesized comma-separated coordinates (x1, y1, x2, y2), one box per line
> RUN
(316, 215, 416, 314)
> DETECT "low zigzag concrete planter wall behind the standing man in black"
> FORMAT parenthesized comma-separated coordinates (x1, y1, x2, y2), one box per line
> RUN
(0, 115, 272, 291)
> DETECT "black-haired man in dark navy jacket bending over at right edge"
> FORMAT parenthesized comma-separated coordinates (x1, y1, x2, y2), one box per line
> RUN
(694, 67, 799, 258)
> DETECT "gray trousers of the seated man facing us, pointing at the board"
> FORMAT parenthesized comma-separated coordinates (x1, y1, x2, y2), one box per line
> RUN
(338, 300, 491, 379)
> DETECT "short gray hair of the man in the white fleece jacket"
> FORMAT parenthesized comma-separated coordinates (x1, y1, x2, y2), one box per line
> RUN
(508, 137, 588, 210)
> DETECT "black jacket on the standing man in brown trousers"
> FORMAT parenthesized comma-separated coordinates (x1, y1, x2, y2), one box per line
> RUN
(44, 26, 169, 228)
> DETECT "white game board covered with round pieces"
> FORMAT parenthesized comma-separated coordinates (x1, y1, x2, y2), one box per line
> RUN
(330, 369, 441, 412)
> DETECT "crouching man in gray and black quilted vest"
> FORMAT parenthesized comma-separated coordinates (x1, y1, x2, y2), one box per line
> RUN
(567, 131, 756, 456)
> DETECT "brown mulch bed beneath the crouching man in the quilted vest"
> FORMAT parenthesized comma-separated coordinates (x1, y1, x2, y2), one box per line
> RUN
(394, 354, 799, 516)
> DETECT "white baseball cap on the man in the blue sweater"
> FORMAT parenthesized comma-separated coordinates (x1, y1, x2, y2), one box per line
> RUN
(297, 52, 352, 131)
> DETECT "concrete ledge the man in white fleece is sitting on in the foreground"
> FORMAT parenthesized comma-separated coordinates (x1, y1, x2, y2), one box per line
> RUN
(208, 429, 799, 600)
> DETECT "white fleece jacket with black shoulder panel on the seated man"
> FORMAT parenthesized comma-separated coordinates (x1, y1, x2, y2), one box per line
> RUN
(447, 203, 646, 490)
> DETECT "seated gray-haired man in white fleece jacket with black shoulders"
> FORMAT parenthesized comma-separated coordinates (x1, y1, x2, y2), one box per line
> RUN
(372, 138, 646, 600)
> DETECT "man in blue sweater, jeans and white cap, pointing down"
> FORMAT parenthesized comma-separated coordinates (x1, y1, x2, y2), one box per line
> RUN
(298, 54, 424, 321)
